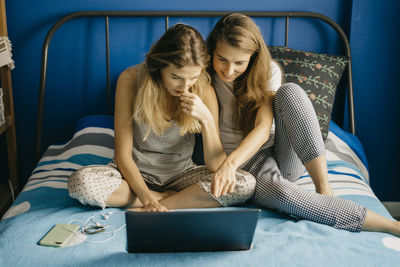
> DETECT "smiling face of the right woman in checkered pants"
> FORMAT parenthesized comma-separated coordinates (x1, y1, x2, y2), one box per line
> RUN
(213, 41, 252, 82)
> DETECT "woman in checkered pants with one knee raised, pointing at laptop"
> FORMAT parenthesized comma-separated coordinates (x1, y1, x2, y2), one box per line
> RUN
(207, 13, 400, 236)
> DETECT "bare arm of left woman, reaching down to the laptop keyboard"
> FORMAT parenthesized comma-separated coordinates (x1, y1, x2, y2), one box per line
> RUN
(114, 68, 167, 211)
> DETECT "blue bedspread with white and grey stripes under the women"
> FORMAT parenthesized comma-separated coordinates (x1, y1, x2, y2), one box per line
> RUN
(0, 116, 400, 266)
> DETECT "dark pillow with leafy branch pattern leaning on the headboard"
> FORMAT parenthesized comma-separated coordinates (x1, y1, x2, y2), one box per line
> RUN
(269, 46, 348, 139)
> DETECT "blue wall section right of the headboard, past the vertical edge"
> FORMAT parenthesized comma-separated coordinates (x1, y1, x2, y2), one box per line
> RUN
(350, 0, 400, 201)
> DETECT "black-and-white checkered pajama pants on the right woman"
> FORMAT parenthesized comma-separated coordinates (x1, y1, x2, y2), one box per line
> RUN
(242, 83, 367, 232)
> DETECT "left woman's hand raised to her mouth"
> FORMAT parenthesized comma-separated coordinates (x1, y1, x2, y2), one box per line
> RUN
(179, 91, 212, 123)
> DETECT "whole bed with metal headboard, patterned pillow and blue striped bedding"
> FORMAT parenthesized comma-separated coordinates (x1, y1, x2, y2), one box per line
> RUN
(0, 12, 400, 266)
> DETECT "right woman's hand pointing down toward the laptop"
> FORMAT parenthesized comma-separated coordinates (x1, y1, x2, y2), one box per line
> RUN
(211, 159, 237, 198)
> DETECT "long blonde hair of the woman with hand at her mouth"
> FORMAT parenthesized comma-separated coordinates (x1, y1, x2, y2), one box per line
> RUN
(133, 24, 210, 139)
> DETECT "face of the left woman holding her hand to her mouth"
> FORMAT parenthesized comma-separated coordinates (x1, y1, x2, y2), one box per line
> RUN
(161, 65, 203, 96)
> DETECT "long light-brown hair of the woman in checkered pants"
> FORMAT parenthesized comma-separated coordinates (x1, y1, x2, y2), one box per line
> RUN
(207, 13, 272, 134)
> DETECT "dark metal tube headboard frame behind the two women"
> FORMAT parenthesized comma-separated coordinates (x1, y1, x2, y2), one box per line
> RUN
(36, 11, 355, 160)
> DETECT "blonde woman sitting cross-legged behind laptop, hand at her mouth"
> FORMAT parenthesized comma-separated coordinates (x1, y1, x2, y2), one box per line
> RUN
(68, 24, 255, 212)
